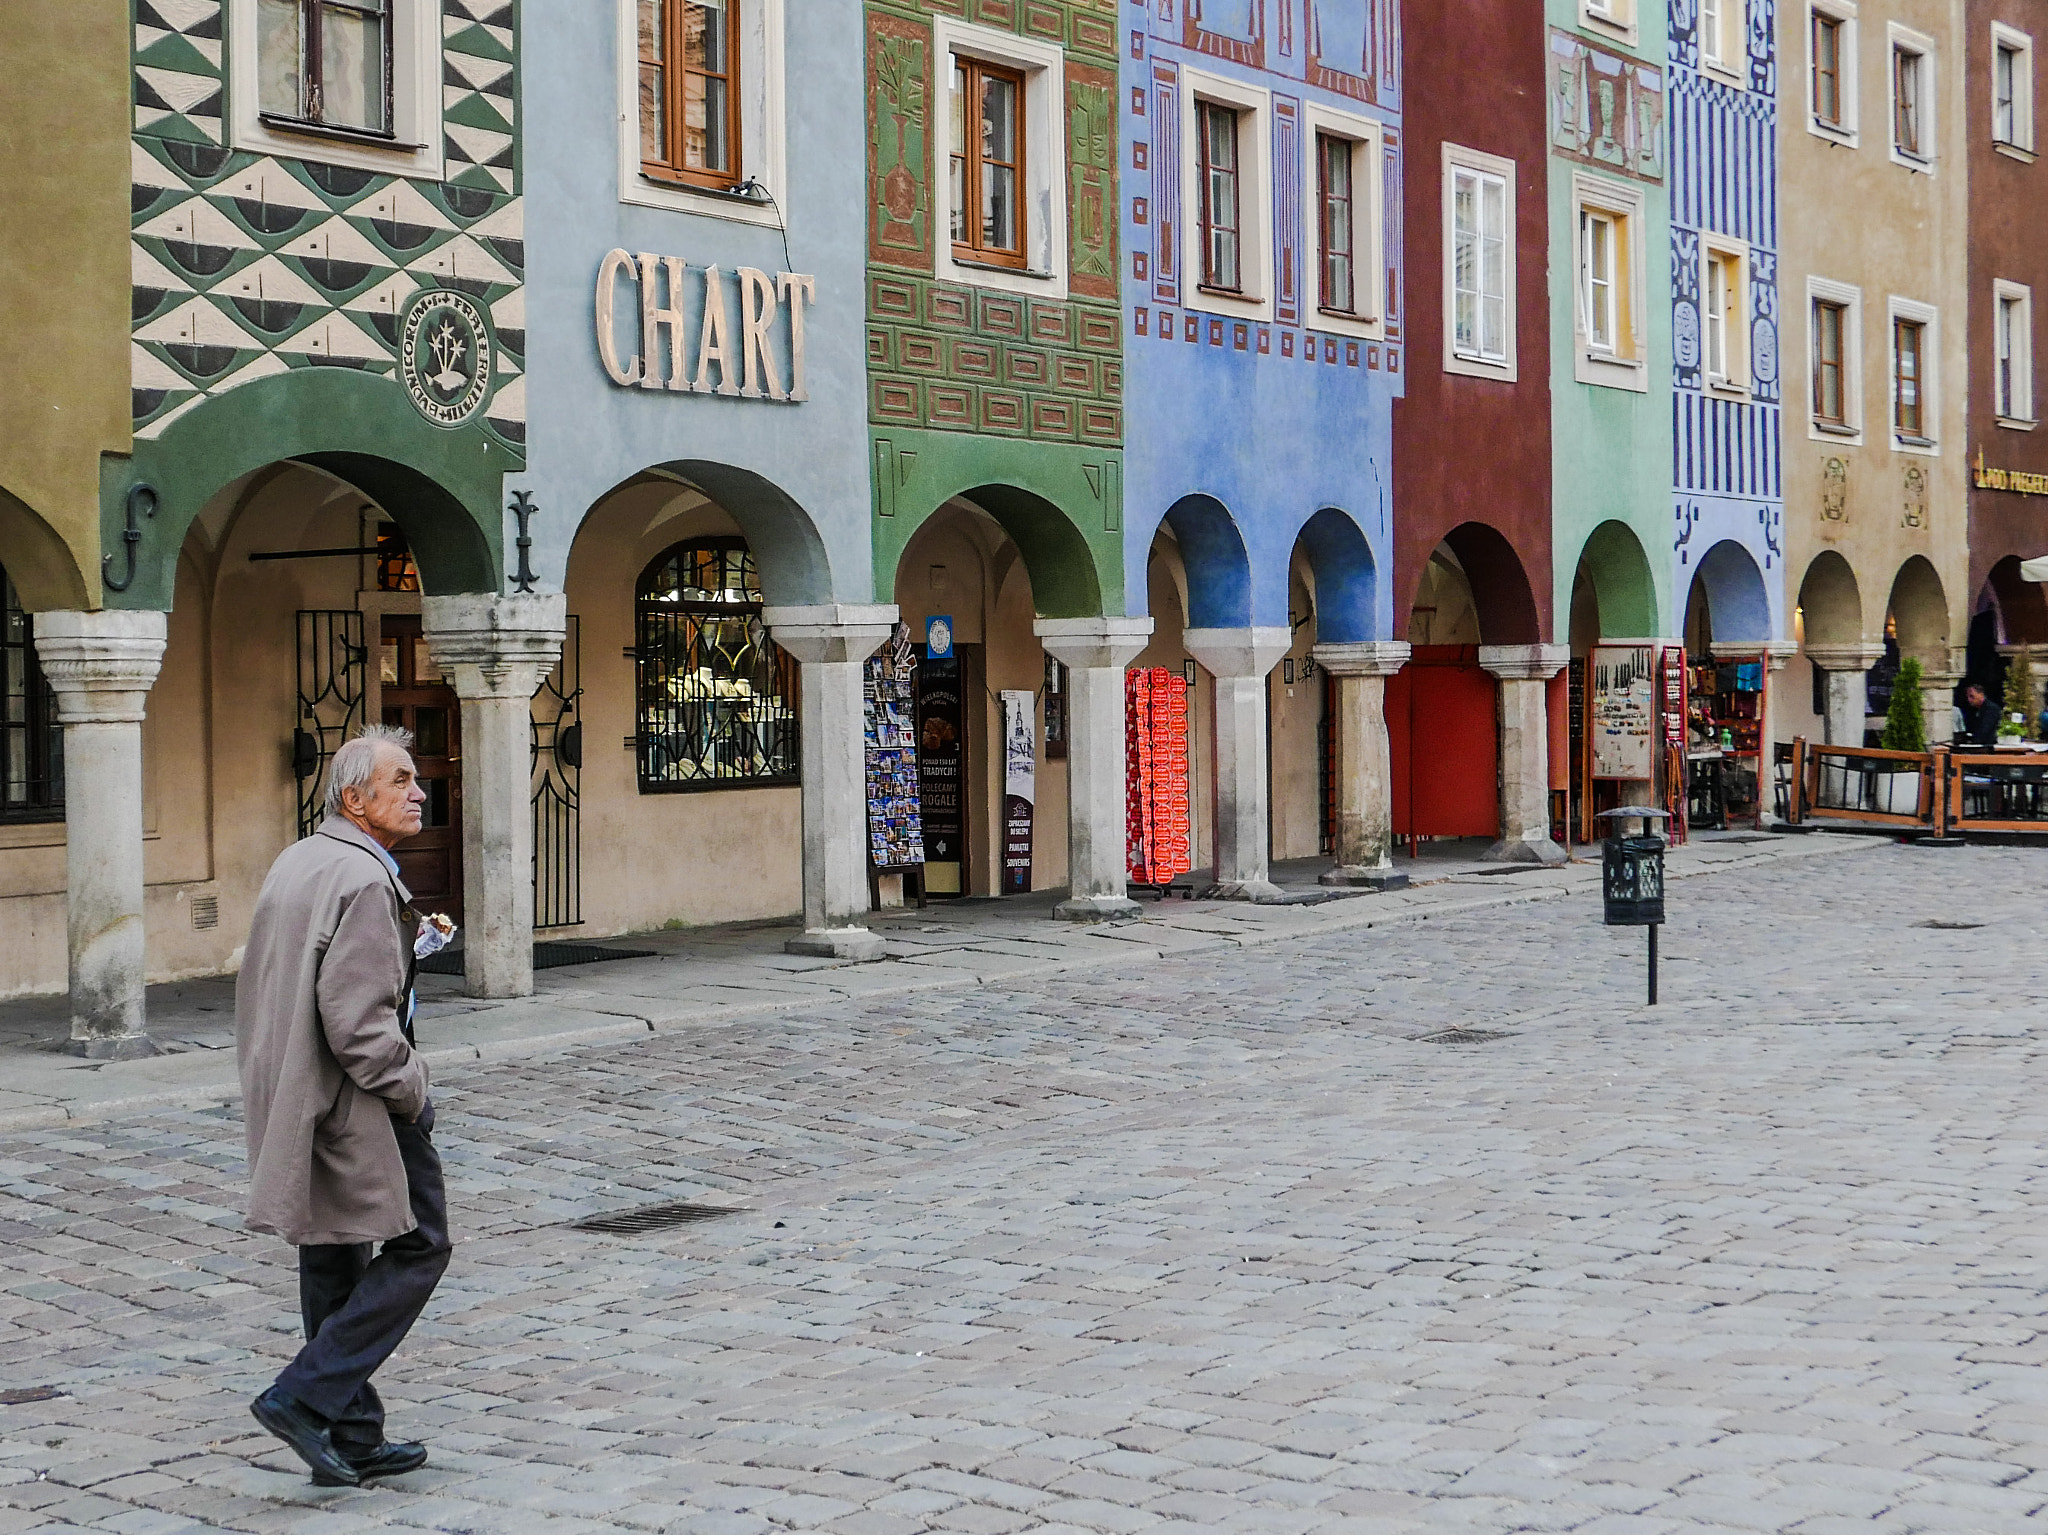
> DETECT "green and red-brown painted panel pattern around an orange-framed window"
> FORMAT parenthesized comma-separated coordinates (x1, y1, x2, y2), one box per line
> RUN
(866, 0, 1124, 446)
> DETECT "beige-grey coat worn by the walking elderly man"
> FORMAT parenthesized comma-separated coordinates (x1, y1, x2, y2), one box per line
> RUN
(236, 817, 426, 1246)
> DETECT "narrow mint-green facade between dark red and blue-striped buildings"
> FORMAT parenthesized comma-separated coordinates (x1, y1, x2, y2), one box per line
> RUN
(1544, 0, 1675, 643)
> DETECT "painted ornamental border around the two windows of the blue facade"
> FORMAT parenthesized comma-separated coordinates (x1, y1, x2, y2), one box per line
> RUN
(1128, 42, 1403, 384)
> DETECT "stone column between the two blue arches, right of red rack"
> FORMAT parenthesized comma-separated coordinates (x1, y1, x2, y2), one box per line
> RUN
(1182, 624, 1292, 901)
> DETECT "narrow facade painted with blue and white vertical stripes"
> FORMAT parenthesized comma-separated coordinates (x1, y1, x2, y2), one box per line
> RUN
(1667, 0, 1786, 641)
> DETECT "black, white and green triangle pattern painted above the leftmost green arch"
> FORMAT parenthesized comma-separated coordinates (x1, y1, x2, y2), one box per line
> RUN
(131, 0, 526, 456)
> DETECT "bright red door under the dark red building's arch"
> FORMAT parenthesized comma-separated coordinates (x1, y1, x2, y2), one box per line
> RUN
(1386, 645, 1501, 837)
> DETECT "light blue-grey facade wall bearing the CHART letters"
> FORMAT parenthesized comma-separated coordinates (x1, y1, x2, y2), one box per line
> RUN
(506, 0, 874, 604)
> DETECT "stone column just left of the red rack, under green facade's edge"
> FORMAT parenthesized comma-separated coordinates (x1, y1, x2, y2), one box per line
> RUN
(1032, 618, 1151, 923)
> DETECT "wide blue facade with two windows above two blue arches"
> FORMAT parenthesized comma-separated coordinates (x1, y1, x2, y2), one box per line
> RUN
(1120, 0, 1403, 643)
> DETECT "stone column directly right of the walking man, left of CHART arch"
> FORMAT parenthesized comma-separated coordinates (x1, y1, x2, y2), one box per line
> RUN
(420, 591, 569, 997)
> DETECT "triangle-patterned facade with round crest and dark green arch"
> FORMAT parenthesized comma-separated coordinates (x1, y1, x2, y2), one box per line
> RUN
(100, 0, 526, 608)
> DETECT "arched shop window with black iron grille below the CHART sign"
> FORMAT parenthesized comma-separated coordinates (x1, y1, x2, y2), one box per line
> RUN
(635, 538, 799, 794)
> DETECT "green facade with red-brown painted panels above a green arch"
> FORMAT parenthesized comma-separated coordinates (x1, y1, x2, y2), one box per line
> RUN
(866, 0, 1124, 618)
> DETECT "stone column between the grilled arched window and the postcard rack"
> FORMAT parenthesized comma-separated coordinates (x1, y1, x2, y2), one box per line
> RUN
(762, 602, 897, 960)
